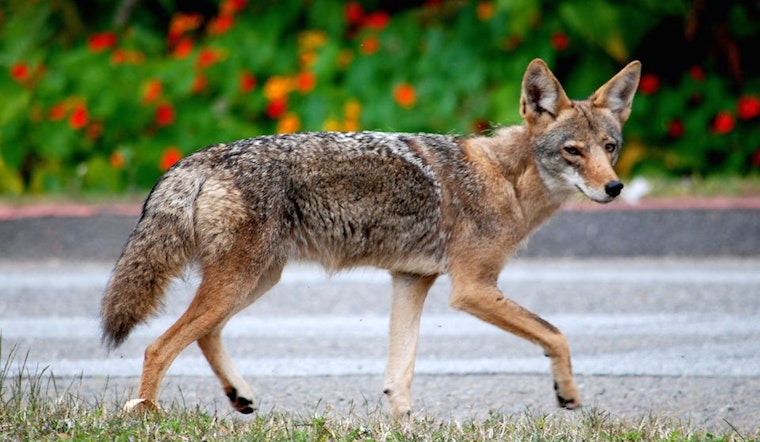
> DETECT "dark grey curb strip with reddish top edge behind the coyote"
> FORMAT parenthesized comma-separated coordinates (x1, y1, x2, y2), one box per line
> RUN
(0, 197, 760, 261)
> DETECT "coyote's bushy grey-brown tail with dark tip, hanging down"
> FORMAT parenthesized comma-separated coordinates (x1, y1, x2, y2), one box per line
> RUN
(101, 168, 202, 349)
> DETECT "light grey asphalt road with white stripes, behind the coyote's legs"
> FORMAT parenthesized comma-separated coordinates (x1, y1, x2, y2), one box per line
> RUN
(0, 256, 760, 432)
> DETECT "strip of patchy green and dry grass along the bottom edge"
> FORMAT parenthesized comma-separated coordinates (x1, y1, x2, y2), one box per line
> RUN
(0, 339, 760, 441)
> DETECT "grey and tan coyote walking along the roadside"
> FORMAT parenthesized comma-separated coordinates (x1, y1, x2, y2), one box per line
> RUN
(102, 59, 641, 417)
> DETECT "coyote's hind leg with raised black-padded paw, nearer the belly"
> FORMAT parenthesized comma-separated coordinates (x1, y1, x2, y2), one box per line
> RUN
(198, 260, 285, 414)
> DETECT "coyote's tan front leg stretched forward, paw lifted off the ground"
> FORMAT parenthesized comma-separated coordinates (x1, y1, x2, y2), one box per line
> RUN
(451, 275, 581, 409)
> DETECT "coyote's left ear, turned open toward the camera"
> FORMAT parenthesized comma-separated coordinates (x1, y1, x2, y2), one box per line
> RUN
(520, 58, 572, 122)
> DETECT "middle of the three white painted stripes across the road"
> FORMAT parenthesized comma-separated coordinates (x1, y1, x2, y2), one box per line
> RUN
(0, 313, 760, 340)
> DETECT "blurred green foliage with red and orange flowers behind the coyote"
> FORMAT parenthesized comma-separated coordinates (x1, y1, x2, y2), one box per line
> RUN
(0, 0, 760, 194)
